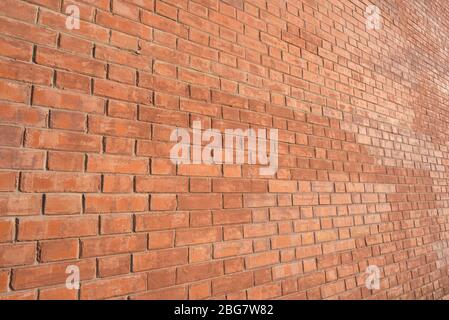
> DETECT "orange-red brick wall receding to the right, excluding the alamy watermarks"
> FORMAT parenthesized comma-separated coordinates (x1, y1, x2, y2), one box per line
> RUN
(0, 0, 449, 299)
